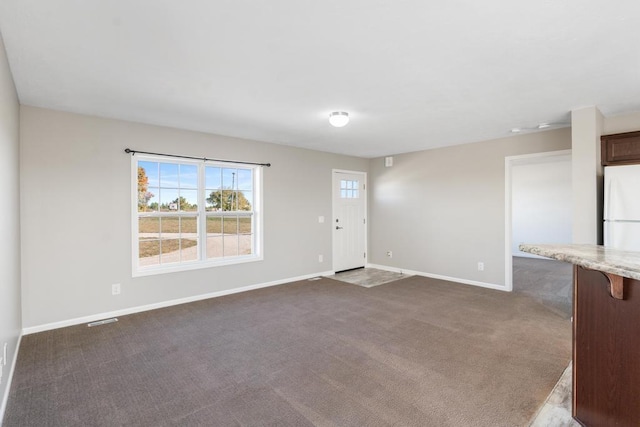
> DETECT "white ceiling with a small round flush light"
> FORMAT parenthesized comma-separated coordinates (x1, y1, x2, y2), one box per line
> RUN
(0, 0, 640, 157)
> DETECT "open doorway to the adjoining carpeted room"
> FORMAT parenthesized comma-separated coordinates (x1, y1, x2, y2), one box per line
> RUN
(505, 150, 572, 317)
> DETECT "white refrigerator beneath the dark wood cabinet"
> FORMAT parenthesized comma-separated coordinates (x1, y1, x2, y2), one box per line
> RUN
(604, 165, 640, 251)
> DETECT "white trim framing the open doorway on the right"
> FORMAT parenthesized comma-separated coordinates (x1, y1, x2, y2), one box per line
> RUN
(504, 150, 571, 292)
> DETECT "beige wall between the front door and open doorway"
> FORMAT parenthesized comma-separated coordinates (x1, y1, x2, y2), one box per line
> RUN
(369, 129, 571, 286)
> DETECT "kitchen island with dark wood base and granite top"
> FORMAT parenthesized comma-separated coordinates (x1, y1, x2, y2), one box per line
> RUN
(520, 244, 640, 426)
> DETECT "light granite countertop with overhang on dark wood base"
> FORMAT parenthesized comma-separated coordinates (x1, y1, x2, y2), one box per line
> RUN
(519, 244, 640, 280)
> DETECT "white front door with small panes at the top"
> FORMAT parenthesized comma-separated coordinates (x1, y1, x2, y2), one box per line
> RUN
(332, 171, 367, 271)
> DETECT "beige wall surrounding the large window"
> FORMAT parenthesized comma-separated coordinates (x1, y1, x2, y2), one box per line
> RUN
(21, 106, 368, 328)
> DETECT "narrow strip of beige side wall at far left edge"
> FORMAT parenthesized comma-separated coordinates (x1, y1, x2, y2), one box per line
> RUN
(0, 31, 22, 416)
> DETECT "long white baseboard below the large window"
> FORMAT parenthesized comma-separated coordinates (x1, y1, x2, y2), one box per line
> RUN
(22, 271, 334, 335)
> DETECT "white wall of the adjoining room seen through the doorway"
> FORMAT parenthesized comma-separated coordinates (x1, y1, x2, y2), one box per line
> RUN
(511, 155, 572, 257)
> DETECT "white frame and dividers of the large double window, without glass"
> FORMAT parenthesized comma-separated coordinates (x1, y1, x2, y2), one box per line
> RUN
(131, 153, 264, 277)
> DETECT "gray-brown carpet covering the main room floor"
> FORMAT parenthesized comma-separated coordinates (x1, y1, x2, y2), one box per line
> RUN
(4, 276, 571, 427)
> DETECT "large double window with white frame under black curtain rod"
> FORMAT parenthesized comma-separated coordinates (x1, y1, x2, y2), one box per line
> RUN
(132, 154, 262, 276)
